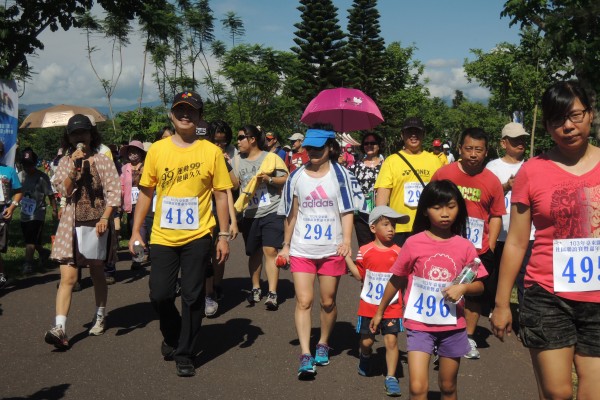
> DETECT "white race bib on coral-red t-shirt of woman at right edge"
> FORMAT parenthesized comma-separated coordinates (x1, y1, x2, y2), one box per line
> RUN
(552, 238, 600, 292)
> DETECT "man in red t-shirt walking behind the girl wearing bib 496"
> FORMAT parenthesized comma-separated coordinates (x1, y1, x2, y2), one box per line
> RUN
(431, 128, 506, 359)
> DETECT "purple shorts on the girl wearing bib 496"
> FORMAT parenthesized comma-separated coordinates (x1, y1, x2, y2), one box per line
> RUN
(406, 329, 471, 358)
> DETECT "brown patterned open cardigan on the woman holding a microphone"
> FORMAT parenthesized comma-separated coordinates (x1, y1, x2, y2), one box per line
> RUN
(50, 154, 121, 264)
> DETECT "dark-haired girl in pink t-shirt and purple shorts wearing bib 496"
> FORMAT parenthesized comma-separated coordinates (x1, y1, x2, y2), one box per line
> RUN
(370, 180, 487, 399)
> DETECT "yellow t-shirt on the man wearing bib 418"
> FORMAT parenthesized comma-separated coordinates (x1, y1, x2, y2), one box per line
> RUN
(140, 138, 233, 247)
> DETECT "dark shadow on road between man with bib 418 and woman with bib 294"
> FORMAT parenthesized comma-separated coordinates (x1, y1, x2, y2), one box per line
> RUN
(195, 318, 264, 368)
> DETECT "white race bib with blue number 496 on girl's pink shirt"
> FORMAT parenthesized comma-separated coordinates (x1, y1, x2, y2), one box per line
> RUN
(404, 276, 456, 325)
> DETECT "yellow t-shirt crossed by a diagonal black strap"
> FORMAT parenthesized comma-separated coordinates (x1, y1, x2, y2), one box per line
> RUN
(375, 151, 442, 232)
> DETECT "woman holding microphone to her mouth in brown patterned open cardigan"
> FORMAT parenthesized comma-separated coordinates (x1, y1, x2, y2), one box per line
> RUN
(45, 114, 121, 350)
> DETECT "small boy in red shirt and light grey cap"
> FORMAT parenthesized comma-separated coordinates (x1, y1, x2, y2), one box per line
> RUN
(346, 206, 408, 396)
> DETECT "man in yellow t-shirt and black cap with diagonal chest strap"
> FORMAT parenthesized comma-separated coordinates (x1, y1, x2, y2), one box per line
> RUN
(375, 117, 442, 246)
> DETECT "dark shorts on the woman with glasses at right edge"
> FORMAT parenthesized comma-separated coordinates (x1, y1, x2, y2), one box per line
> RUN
(519, 284, 600, 357)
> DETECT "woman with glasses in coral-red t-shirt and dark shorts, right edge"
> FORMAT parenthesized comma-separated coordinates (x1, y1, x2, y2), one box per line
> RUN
(492, 82, 600, 399)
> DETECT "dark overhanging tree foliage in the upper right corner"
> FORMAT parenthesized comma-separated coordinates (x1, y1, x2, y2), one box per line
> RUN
(501, 0, 600, 134)
